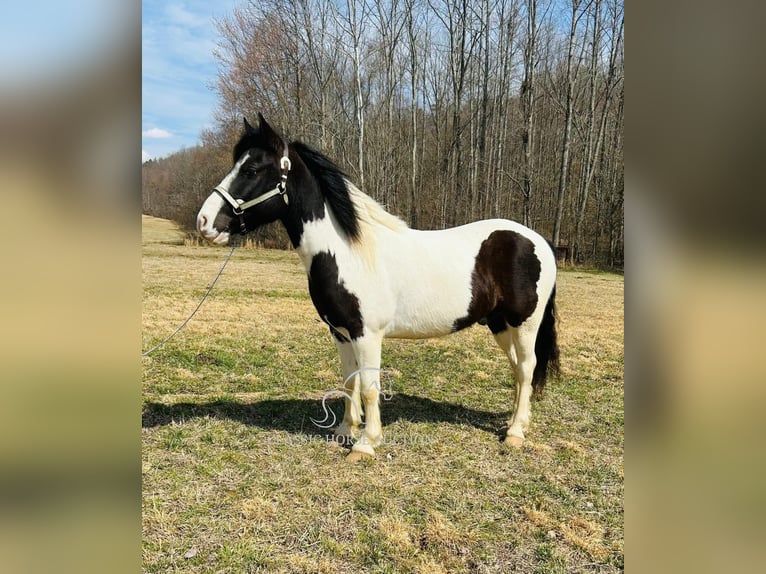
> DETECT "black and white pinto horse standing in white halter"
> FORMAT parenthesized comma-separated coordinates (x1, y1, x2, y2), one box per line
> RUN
(197, 114, 558, 461)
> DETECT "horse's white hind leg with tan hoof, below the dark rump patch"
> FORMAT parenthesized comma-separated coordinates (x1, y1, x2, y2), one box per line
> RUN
(505, 326, 537, 447)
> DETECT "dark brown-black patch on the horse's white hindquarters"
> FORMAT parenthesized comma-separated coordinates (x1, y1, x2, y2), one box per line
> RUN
(452, 230, 540, 334)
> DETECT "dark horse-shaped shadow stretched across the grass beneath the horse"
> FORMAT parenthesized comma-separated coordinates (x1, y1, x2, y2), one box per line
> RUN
(141, 394, 509, 436)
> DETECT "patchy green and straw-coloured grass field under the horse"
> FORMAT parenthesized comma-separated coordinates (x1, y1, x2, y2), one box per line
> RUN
(142, 217, 624, 574)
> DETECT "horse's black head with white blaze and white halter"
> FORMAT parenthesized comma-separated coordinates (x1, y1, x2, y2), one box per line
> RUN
(197, 114, 290, 244)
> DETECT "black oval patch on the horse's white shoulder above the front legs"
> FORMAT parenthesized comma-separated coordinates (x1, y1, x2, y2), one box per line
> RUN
(309, 251, 364, 341)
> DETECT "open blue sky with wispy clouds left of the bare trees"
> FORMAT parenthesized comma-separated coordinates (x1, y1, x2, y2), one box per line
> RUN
(141, 0, 244, 162)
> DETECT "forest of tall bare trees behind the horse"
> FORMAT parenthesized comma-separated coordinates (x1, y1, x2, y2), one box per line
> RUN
(142, 0, 625, 268)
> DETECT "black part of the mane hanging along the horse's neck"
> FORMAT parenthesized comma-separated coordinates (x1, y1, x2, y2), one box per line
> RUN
(290, 145, 360, 241)
